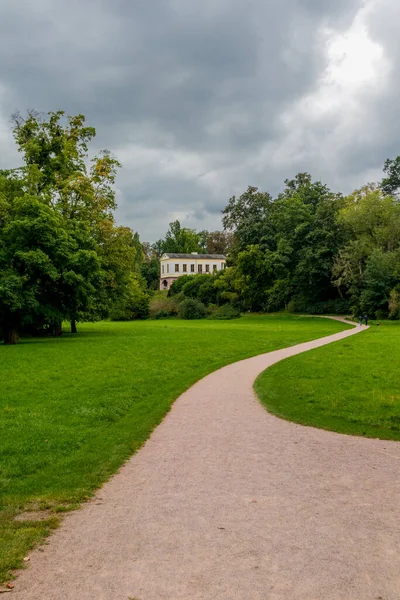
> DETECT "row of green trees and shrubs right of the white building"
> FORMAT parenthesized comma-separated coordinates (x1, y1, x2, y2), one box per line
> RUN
(159, 172, 400, 319)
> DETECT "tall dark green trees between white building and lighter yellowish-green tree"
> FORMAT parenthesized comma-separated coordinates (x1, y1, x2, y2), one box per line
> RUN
(223, 173, 343, 311)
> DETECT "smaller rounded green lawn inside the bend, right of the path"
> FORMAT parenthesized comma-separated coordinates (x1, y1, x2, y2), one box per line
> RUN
(255, 321, 400, 440)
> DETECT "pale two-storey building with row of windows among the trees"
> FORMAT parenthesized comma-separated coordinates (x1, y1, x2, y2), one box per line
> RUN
(160, 252, 226, 290)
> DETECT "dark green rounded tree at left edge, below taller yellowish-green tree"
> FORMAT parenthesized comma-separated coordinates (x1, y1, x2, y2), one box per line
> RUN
(0, 194, 101, 343)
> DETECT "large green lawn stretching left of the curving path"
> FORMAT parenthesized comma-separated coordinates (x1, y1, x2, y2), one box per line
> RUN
(0, 315, 345, 580)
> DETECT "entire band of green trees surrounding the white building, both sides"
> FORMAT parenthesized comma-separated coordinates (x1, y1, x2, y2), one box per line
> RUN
(0, 111, 400, 343)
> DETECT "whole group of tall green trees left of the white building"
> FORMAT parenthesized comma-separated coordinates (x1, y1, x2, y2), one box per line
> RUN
(0, 111, 145, 343)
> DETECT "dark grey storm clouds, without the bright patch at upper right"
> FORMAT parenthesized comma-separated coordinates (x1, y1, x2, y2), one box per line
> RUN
(0, 0, 397, 239)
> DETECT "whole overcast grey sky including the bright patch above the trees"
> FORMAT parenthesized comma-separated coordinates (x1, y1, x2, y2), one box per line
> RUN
(0, 0, 400, 241)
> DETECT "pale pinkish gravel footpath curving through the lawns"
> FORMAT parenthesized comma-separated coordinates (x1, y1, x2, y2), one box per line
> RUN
(11, 316, 400, 600)
